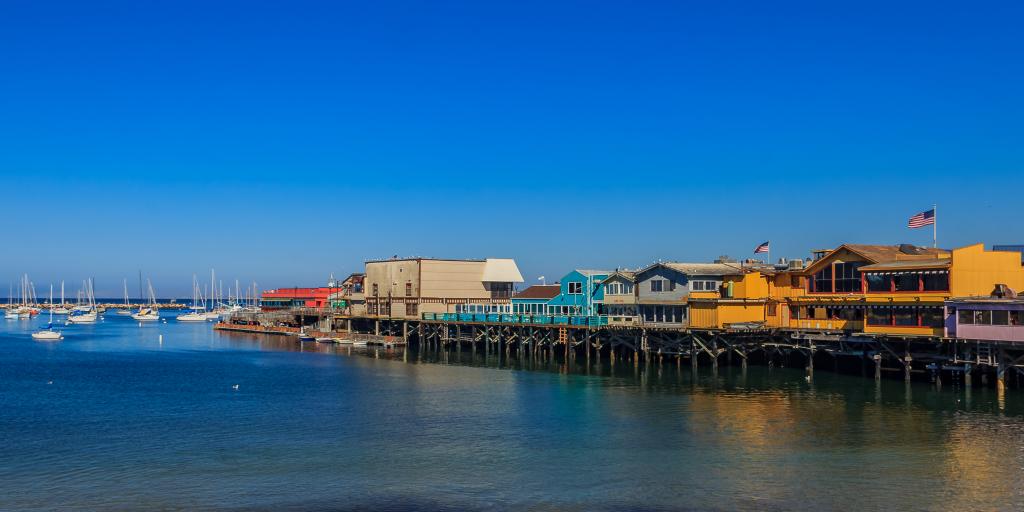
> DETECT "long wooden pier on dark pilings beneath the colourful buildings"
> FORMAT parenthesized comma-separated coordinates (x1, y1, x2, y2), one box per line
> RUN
(216, 310, 1024, 388)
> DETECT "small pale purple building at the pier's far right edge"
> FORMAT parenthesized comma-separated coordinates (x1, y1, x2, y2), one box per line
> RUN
(946, 297, 1024, 343)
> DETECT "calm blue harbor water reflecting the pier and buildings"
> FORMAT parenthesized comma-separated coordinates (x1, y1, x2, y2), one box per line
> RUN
(0, 314, 1024, 510)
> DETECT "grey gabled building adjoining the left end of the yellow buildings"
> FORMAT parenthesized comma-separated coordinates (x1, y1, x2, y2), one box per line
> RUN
(634, 262, 740, 327)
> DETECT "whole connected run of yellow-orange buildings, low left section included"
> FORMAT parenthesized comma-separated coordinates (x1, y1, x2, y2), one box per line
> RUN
(687, 244, 1024, 336)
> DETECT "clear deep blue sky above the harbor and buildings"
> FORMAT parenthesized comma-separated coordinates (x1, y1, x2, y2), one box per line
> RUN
(0, 0, 1024, 296)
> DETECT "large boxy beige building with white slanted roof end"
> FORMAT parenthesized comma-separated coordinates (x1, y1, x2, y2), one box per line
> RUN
(364, 258, 523, 318)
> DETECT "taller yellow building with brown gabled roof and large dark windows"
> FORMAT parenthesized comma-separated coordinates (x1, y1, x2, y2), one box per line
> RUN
(786, 244, 1024, 336)
